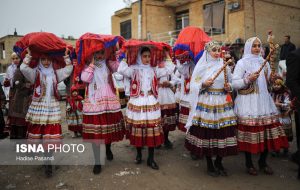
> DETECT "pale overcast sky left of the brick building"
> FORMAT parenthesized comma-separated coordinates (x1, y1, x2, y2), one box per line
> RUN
(0, 0, 131, 38)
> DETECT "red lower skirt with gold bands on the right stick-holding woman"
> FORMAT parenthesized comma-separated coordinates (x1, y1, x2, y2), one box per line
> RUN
(238, 122, 289, 154)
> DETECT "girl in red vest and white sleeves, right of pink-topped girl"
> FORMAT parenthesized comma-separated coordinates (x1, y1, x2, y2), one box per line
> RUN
(118, 47, 164, 170)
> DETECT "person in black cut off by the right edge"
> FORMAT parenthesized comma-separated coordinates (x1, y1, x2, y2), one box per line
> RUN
(286, 48, 300, 179)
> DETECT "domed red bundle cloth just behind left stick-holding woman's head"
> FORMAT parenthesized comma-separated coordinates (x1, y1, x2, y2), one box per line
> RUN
(174, 26, 211, 61)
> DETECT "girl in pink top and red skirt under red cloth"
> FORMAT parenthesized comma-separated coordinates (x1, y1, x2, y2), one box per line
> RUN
(81, 49, 125, 174)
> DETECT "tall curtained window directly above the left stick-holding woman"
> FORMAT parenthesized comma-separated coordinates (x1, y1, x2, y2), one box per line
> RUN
(203, 0, 225, 35)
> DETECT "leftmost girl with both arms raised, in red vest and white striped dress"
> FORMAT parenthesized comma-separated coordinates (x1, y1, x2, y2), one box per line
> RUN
(20, 48, 73, 177)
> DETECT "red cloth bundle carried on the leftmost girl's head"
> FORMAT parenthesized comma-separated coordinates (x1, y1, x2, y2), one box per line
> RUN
(15, 32, 73, 69)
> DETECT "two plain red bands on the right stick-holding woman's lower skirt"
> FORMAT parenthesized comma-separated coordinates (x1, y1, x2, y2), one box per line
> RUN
(238, 123, 289, 154)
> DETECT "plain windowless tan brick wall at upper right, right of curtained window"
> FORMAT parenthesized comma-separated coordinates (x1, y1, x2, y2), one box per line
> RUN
(245, 0, 300, 47)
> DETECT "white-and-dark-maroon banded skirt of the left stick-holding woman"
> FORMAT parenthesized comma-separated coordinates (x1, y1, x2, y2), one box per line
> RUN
(185, 89, 237, 157)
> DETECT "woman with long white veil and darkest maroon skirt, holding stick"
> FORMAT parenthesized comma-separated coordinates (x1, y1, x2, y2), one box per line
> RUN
(185, 41, 237, 177)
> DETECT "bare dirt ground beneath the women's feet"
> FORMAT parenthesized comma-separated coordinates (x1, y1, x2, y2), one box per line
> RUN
(0, 103, 300, 190)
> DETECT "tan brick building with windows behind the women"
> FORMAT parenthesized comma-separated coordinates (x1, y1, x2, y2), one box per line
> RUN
(111, 0, 300, 47)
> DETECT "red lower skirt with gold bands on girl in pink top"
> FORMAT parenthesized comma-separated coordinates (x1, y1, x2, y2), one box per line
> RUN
(82, 111, 125, 144)
